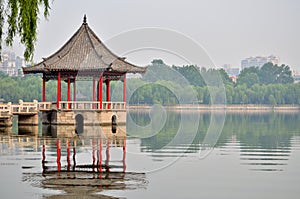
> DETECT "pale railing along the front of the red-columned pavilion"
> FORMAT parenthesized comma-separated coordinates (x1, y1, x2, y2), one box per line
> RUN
(58, 101, 126, 110)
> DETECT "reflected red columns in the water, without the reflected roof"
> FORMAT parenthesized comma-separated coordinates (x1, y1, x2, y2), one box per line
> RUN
(42, 136, 126, 173)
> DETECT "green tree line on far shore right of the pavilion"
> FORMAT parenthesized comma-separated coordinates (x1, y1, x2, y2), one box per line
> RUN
(129, 60, 300, 105)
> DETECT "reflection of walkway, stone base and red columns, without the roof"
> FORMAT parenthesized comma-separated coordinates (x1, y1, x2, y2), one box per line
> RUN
(0, 122, 126, 172)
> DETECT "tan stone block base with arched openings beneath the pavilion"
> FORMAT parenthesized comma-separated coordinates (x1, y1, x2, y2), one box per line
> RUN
(42, 110, 126, 137)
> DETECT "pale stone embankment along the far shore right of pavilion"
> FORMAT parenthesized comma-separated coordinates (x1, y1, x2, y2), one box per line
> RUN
(127, 104, 300, 113)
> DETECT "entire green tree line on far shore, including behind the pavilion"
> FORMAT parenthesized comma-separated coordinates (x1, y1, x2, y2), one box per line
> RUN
(0, 59, 300, 105)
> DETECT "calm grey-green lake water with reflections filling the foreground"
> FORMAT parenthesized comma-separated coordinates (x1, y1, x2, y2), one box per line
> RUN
(0, 111, 300, 199)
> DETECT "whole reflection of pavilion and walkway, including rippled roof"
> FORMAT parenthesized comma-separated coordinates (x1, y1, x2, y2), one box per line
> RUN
(0, 126, 146, 198)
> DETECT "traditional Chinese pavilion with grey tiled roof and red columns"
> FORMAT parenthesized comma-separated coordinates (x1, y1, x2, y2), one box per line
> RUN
(23, 16, 146, 127)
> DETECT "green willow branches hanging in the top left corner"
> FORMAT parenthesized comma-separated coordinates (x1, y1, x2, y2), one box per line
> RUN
(0, 0, 50, 61)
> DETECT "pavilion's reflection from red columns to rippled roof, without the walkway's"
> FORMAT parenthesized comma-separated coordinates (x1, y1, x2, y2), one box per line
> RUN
(37, 135, 145, 198)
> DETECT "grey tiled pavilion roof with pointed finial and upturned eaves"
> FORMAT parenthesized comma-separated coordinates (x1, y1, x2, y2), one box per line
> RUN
(23, 16, 146, 76)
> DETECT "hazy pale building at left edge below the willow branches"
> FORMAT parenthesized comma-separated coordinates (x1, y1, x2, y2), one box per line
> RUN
(0, 51, 25, 76)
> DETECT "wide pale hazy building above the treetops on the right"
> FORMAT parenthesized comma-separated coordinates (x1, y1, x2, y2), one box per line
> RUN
(241, 55, 279, 70)
